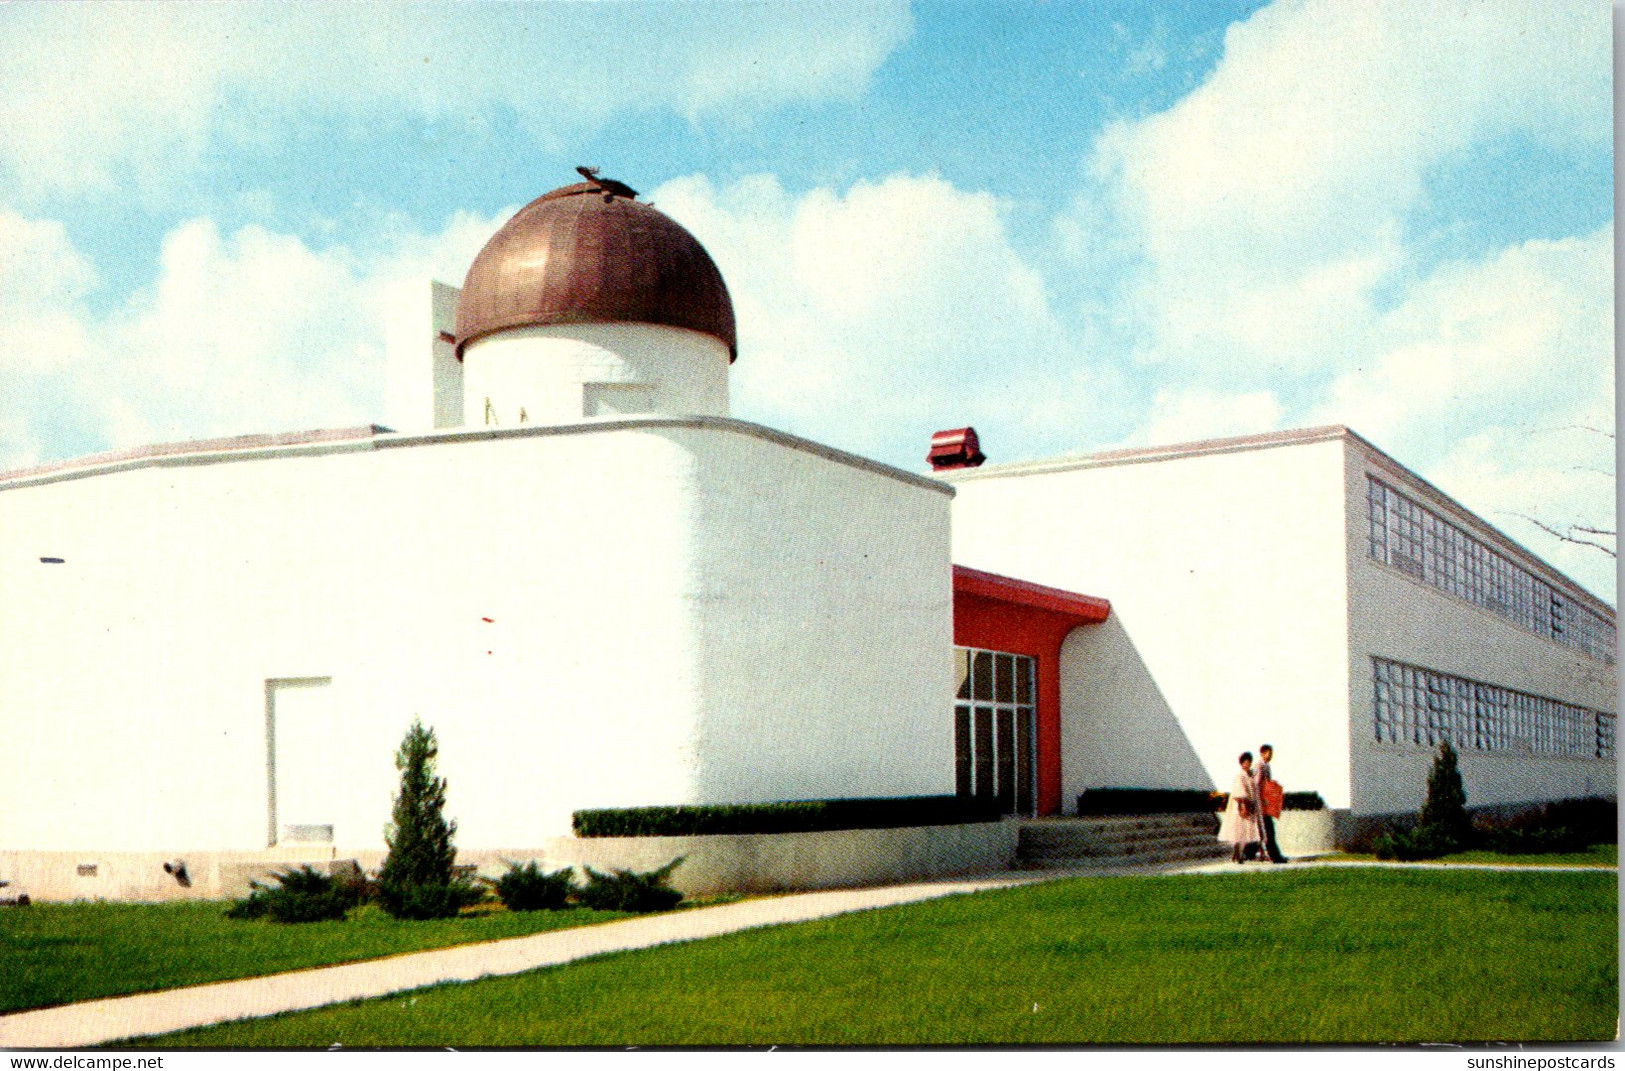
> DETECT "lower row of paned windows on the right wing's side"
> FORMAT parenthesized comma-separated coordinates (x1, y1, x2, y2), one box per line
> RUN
(1372, 658, 1614, 759)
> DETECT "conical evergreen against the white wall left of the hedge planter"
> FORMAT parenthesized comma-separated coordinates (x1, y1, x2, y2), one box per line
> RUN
(379, 718, 457, 913)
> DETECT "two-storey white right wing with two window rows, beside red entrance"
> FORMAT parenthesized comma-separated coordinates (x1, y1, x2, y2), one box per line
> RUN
(943, 427, 1617, 816)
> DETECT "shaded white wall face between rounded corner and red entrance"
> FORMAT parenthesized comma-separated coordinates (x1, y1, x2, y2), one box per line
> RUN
(684, 432, 954, 801)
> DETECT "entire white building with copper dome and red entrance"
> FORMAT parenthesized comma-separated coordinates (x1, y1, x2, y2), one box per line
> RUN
(0, 173, 1615, 897)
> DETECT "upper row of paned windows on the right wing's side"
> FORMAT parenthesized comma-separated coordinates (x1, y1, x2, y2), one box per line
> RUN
(1365, 476, 1619, 665)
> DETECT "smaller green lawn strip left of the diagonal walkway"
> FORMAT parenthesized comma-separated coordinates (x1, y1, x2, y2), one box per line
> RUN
(0, 902, 622, 1012)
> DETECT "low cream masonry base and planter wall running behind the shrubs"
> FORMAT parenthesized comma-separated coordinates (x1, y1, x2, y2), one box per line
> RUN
(0, 822, 1019, 900)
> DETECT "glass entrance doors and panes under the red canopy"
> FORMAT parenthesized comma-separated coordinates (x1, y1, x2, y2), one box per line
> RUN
(954, 647, 1038, 816)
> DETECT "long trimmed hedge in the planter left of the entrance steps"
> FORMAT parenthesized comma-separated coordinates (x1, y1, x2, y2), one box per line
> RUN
(572, 796, 999, 837)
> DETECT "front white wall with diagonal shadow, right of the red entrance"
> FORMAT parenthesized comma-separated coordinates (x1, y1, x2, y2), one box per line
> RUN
(947, 436, 1350, 808)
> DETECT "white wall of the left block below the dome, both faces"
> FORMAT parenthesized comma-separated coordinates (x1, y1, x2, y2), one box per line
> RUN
(0, 418, 952, 852)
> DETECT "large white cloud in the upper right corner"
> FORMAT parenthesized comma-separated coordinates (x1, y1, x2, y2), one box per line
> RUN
(1073, 0, 1612, 375)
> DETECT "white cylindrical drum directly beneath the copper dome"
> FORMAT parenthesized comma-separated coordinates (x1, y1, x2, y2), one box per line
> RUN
(463, 323, 728, 427)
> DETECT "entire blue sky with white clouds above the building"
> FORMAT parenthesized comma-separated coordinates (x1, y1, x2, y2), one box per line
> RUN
(0, 0, 1614, 598)
